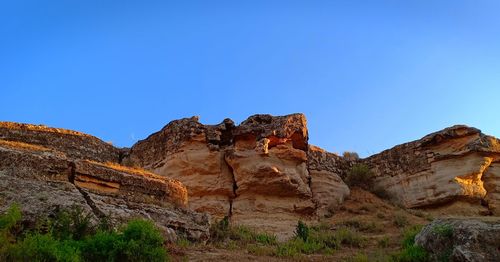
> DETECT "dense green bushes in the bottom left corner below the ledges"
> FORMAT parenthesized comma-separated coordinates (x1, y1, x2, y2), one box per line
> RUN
(0, 205, 168, 261)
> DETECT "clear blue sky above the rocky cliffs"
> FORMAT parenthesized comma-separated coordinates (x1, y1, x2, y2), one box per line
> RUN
(0, 0, 500, 156)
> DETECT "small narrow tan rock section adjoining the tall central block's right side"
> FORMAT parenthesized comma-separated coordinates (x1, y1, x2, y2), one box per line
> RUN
(308, 146, 353, 217)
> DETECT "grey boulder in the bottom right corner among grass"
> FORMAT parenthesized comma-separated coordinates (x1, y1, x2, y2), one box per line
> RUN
(415, 218, 500, 262)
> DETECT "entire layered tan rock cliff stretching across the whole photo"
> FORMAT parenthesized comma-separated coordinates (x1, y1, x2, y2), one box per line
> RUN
(0, 114, 500, 239)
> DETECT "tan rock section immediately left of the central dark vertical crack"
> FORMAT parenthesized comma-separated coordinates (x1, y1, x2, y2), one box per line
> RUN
(125, 117, 234, 219)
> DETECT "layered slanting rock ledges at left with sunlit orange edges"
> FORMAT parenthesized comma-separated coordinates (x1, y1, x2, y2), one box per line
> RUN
(0, 123, 209, 242)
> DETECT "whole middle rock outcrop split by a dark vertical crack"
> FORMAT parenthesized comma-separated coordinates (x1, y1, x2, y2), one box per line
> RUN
(124, 114, 349, 237)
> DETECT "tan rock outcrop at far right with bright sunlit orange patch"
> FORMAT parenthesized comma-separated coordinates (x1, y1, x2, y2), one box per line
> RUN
(364, 126, 500, 215)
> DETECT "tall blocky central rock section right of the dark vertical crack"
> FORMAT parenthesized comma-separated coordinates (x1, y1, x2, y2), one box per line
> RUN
(226, 114, 315, 234)
